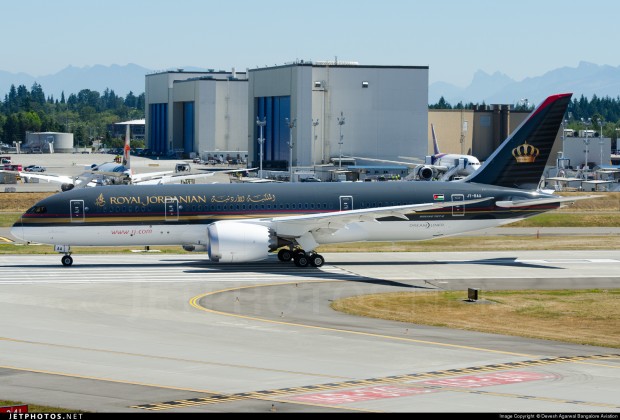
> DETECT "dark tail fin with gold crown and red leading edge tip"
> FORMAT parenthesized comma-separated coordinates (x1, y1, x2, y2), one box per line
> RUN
(464, 93, 572, 189)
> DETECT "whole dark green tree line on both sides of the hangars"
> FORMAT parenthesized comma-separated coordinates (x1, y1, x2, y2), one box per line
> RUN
(0, 82, 620, 145)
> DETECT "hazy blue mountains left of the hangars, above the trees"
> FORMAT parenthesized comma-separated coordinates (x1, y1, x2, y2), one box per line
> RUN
(0, 64, 152, 99)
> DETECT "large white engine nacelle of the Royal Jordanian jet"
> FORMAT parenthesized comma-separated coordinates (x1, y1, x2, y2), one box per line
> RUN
(207, 222, 277, 263)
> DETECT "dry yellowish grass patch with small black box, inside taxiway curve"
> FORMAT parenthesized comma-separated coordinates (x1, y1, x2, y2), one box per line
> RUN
(332, 289, 620, 348)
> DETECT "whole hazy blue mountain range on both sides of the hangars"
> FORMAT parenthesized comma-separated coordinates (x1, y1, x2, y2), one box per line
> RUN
(0, 62, 620, 106)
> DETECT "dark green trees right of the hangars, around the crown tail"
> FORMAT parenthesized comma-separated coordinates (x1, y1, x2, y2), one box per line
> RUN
(429, 95, 620, 140)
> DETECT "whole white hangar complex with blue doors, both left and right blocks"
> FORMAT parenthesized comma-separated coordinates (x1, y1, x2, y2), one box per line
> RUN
(145, 61, 428, 169)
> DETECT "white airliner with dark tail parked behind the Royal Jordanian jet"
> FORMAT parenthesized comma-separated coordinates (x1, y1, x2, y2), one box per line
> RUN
(355, 124, 480, 181)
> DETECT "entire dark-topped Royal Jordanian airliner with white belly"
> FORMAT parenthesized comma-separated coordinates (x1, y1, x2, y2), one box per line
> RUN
(11, 94, 587, 267)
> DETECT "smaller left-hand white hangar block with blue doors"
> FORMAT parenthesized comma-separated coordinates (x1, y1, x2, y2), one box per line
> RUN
(145, 69, 248, 157)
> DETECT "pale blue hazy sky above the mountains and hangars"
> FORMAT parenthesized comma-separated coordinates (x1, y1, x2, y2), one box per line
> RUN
(0, 0, 620, 86)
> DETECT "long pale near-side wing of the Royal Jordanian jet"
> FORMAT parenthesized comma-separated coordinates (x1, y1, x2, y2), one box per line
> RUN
(265, 197, 493, 237)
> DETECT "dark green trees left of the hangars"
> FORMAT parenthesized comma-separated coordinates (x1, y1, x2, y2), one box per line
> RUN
(0, 82, 145, 145)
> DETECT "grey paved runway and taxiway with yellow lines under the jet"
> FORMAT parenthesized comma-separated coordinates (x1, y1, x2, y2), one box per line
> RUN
(0, 251, 620, 413)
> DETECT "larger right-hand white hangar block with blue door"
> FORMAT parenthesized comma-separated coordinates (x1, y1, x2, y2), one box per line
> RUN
(248, 61, 428, 169)
